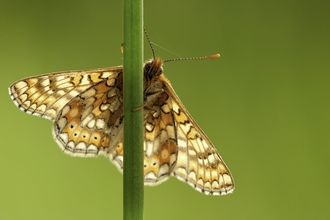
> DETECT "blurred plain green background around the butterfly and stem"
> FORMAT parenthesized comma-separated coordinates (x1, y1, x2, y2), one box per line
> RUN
(0, 0, 330, 220)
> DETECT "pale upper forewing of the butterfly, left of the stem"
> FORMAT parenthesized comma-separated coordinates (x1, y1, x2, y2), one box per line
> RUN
(9, 66, 122, 120)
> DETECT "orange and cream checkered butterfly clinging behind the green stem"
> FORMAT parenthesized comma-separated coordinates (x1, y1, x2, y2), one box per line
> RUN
(9, 50, 234, 195)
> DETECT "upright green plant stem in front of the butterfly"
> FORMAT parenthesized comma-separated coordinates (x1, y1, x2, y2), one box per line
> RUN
(123, 0, 144, 220)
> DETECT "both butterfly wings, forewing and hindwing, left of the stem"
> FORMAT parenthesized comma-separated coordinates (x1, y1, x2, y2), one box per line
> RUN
(9, 66, 123, 165)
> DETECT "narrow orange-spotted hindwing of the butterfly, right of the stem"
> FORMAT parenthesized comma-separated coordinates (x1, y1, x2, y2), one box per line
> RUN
(144, 102, 177, 186)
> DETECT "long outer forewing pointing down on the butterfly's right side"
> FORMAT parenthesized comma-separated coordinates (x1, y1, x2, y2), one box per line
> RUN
(164, 78, 234, 195)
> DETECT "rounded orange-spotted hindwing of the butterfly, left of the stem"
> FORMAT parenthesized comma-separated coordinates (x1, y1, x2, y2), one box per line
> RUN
(53, 69, 124, 162)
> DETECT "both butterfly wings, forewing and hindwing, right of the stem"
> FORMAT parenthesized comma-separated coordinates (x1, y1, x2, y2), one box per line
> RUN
(144, 73, 234, 195)
